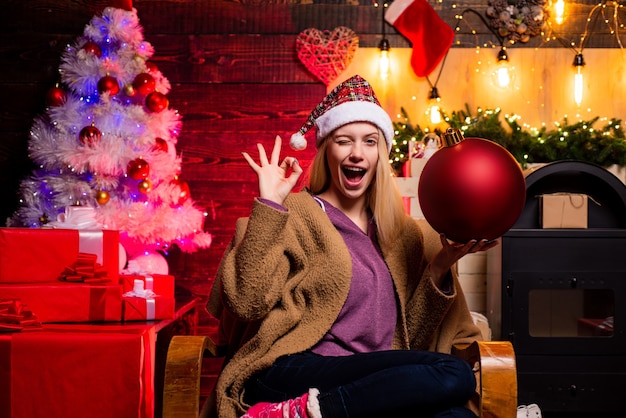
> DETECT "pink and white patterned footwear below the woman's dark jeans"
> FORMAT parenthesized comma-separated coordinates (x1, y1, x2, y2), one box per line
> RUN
(241, 389, 322, 418)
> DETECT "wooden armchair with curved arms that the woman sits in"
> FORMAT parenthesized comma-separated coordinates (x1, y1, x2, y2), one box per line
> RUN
(163, 335, 517, 418)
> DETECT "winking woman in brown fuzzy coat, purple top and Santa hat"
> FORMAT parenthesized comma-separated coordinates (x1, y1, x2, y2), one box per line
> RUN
(208, 76, 495, 418)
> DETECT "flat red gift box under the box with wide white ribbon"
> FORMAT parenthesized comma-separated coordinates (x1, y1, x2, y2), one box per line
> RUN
(0, 281, 122, 323)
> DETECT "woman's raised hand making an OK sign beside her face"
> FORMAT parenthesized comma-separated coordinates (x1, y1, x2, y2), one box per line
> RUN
(242, 135, 303, 205)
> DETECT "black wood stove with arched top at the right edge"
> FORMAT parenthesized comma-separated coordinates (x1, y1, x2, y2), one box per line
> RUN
(487, 161, 626, 417)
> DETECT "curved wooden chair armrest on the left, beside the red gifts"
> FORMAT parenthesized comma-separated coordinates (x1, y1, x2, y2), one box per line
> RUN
(163, 335, 224, 418)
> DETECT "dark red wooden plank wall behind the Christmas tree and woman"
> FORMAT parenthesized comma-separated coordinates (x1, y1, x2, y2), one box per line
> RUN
(0, 0, 618, 310)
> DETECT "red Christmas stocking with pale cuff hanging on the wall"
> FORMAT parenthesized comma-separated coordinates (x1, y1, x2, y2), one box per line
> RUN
(385, 0, 454, 77)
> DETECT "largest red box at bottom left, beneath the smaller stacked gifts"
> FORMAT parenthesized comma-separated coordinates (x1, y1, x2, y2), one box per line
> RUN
(0, 323, 156, 418)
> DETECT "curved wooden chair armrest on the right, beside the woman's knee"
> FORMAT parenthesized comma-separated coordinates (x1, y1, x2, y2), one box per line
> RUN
(452, 341, 517, 418)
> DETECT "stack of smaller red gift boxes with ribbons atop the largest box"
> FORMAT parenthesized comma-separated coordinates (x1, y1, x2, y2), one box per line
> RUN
(0, 228, 174, 323)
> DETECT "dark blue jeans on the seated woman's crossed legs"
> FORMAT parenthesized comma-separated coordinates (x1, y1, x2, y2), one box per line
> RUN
(245, 350, 476, 418)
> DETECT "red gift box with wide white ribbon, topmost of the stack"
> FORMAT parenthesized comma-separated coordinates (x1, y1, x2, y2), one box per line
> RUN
(0, 228, 120, 283)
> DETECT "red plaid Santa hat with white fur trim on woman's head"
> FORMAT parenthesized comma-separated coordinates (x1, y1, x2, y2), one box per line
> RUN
(289, 75, 393, 151)
